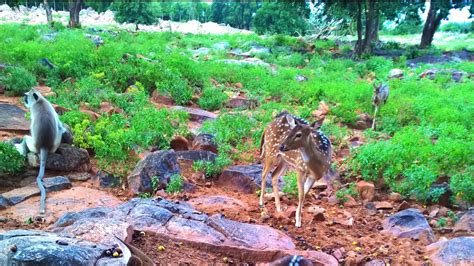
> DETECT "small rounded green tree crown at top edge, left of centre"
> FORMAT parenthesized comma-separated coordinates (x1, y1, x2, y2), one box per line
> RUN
(111, 1, 160, 25)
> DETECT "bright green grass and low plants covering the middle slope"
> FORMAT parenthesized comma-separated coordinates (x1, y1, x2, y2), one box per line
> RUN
(0, 24, 474, 202)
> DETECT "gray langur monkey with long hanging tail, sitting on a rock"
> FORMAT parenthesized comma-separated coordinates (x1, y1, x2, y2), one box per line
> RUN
(15, 89, 65, 214)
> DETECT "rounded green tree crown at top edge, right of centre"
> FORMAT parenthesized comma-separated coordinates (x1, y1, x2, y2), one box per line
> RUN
(253, 1, 309, 35)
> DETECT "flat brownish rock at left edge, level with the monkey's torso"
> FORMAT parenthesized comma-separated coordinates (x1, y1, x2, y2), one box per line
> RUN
(0, 104, 30, 131)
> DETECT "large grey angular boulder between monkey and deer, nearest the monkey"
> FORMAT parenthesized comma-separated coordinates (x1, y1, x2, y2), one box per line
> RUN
(127, 150, 180, 194)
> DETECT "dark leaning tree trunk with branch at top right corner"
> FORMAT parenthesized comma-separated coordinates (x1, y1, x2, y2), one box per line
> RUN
(420, 0, 472, 48)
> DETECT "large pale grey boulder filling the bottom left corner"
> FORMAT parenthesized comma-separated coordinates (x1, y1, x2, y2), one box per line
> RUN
(0, 230, 128, 266)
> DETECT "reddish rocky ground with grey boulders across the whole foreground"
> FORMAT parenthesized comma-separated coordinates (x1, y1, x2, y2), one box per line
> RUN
(0, 88, 474, 265)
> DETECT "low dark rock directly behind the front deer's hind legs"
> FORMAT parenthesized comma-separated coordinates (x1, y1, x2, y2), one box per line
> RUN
(216, 164, 283, 194)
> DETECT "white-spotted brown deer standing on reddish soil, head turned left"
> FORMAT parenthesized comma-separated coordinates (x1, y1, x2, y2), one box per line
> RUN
(259, 111, 332, 227)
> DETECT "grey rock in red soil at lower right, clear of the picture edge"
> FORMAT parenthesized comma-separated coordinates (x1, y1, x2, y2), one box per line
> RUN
(383, 208, 435, 242)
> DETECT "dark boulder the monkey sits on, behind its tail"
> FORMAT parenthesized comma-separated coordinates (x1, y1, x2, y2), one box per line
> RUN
(27, 143, 90, 172)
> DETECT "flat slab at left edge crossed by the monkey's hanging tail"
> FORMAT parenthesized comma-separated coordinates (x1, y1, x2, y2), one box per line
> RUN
(2, 176, 72, 205)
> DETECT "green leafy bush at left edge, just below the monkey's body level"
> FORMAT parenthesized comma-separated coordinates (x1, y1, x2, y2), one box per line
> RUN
(0, 142, 25, 175)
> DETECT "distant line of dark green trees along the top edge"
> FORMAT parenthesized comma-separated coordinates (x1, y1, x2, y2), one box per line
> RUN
(5, 0, 474, 55)
